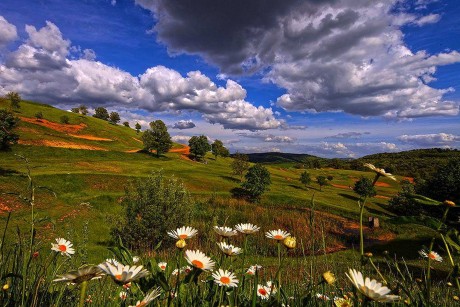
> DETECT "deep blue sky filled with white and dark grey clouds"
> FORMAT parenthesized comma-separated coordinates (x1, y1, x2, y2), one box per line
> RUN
(0, 0, 460, 158)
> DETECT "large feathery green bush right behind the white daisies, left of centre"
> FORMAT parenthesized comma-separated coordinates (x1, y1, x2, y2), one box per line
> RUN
(111, 172, 192, 250)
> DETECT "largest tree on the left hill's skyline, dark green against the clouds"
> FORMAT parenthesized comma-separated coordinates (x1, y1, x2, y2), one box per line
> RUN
(142, 120, 172, 157)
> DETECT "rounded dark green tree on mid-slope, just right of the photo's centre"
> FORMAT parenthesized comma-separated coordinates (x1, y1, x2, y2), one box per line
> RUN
(241, 164, 271, 202)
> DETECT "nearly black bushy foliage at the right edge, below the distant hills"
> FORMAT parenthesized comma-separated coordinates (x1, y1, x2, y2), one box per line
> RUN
(417, 158, 460, 204)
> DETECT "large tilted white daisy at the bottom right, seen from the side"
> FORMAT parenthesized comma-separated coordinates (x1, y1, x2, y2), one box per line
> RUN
(345, 269, 400, 303)
